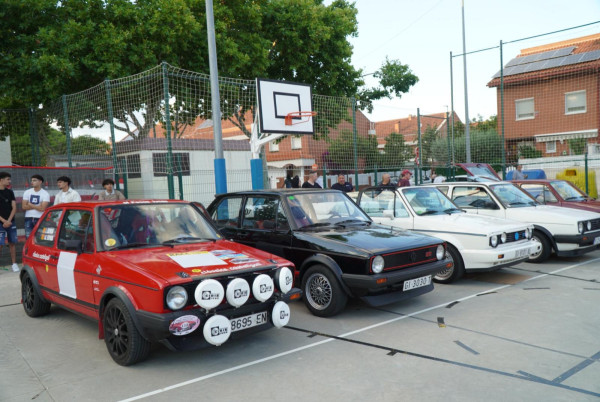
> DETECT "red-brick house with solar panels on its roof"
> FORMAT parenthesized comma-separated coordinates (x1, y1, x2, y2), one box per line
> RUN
(487, 34, 600, 158)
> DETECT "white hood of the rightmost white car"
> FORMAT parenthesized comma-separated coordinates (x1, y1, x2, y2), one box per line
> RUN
(506, 205, 600, 225)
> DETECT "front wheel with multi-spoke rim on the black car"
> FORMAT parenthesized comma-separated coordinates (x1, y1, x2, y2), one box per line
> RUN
(302, 265, 348, 317)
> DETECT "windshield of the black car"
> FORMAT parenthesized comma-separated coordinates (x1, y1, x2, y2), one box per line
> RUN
(287, 191, 371, 228)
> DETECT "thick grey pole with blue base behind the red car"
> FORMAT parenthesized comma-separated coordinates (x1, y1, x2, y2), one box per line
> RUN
(206, 0, 227, 194)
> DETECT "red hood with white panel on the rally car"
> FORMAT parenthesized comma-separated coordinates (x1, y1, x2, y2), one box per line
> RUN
(103, 240, 292, 282)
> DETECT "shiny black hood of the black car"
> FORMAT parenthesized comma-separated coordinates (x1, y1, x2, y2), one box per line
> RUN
(294, 224, 443, 255)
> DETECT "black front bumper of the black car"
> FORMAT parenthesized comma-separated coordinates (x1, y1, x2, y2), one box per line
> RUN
(342, 259, 452, 306)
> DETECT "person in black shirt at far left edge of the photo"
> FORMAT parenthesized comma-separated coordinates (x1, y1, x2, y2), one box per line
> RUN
(0, 172, 20, 272)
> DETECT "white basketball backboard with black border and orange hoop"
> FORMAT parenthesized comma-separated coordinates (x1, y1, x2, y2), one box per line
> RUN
(256, 78, 314, 134)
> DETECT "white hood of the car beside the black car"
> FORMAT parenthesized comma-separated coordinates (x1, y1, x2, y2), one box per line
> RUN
(414, 213, 529, 235)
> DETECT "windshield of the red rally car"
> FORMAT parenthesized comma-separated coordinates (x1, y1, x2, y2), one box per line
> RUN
(99, 203, 219, 250)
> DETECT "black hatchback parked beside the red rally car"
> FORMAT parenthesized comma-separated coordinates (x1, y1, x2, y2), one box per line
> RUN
(207, 189, 452, 317)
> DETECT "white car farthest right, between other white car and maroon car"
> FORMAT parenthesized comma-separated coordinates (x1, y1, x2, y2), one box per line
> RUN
(433, 181, 600, 262)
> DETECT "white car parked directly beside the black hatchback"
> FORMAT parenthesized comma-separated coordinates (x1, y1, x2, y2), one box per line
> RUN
(356, 187, 541, 283)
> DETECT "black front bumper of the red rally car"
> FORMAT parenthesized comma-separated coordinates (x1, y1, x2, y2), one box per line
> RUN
(135, 288, 302, 351)
